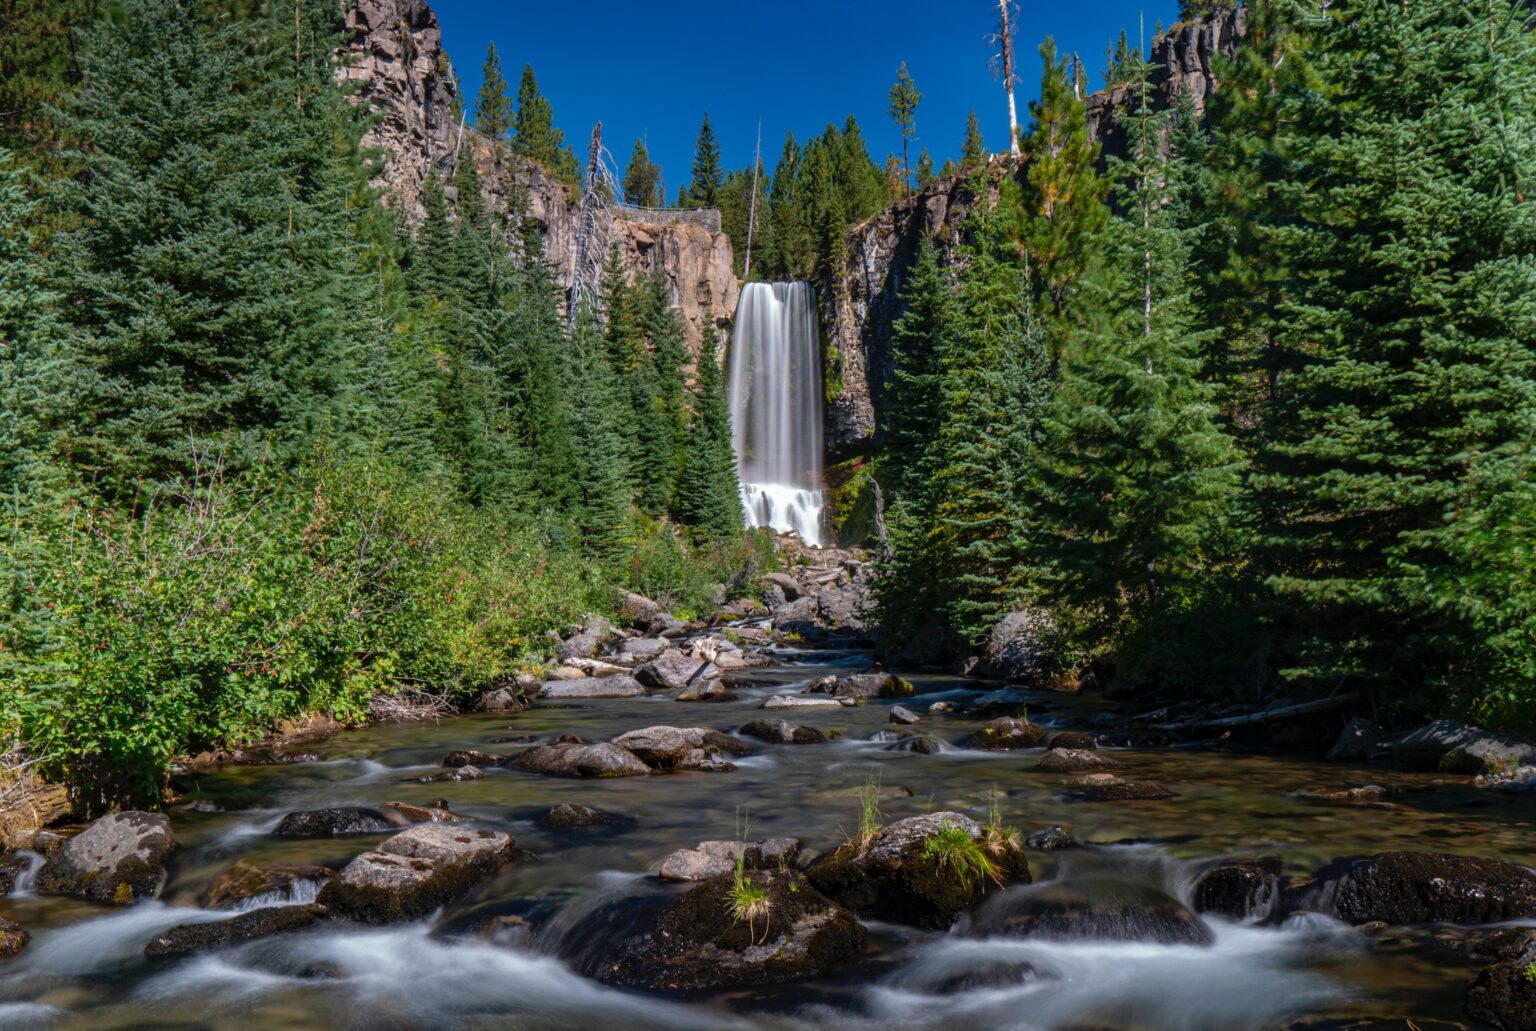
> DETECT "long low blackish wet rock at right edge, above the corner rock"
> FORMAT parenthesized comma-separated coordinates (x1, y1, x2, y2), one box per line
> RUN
(1316, 851, 1536, 923)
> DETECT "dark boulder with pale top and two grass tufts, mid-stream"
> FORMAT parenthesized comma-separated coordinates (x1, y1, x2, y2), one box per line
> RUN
(806, 813, 1029, 930)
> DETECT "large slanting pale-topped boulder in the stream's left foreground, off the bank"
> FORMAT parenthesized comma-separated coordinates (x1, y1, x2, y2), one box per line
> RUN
(318, 824, 515, 923)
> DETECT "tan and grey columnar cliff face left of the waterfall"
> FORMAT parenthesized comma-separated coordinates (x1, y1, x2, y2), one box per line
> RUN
(338, 0, 737, 353)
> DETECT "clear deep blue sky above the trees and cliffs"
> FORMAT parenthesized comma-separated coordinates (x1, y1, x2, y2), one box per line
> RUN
(432, 0, 1178, 200)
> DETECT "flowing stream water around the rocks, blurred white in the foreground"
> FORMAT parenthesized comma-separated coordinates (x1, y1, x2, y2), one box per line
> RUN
(0, 651, 1536, 1031)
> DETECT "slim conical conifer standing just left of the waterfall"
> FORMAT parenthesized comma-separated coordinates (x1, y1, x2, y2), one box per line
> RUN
(677, 330, 742, 539)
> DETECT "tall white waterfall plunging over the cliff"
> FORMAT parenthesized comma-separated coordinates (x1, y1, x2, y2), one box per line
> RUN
(730, 283, 822, 545)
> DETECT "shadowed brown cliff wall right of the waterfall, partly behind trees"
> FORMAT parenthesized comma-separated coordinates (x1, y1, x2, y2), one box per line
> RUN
(817, 9, 1246, 458)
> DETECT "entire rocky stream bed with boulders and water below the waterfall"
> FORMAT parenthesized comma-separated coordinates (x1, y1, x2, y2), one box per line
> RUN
(0, 546, 1536, 1031)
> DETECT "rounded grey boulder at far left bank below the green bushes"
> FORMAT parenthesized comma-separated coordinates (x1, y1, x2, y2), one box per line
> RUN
(37, 813, 175, 905)
